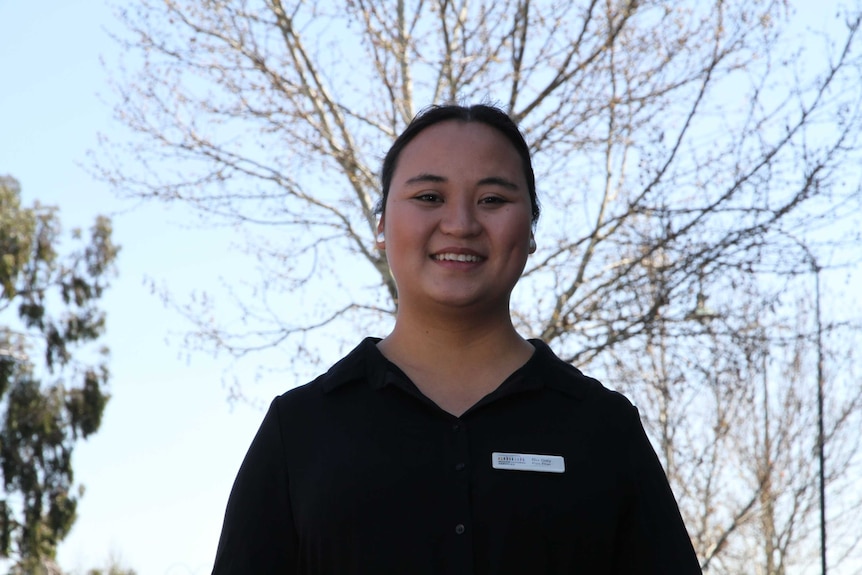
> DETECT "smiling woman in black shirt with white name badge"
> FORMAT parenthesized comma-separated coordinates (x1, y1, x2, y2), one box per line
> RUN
(213, 106, 700, 575)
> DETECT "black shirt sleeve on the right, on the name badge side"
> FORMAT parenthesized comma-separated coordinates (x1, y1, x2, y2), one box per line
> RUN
(616, 408, 702, 575)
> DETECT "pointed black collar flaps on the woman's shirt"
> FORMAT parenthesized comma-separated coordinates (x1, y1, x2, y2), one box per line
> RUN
(319, 337, 601, 399)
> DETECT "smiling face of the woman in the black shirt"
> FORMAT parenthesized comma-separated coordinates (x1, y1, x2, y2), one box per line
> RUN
(379, 120, 531, 312)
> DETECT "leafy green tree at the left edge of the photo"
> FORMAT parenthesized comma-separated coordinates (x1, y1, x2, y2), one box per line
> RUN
(0, 176, 118, 573)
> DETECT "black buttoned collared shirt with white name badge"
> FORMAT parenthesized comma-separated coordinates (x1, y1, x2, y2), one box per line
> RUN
(213, 338, 701, 575)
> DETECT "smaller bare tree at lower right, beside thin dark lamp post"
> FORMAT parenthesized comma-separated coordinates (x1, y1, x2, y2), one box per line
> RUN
(602, 280, 862, 575)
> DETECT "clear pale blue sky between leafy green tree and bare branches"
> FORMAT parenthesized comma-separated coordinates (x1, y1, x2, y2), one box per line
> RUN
(0, 0, 290, 575)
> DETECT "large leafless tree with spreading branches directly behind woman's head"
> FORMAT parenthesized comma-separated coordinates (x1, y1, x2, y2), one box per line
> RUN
(96, 0, 862, 573)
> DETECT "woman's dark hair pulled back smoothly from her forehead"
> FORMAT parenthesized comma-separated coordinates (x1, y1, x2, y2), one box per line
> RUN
(375, 104, 539, 224)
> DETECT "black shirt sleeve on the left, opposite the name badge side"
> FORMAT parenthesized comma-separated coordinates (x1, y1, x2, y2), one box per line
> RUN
(212, 400, 296, 575)
